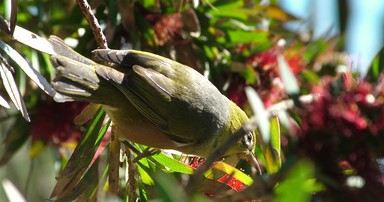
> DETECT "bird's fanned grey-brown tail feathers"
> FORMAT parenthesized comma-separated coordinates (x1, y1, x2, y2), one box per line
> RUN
(49, 36, 117, 104)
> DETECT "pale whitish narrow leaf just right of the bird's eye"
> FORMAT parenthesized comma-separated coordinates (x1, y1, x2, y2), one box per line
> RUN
(245, 87, 270, 143)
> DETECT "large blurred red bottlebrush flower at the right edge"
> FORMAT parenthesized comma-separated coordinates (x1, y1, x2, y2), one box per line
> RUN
(299, 75, 384, 201)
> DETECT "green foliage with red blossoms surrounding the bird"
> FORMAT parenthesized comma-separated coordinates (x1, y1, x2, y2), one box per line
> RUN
(0, 0, 384, 201)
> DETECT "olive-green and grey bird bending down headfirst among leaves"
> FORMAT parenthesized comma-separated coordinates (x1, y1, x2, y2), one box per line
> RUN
(49, 36, 258, 170)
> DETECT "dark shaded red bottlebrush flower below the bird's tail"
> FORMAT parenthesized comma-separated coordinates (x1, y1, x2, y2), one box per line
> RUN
(31, 100, 87, 144)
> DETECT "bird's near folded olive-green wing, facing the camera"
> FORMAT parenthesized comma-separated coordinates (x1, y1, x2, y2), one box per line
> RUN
(103, 66, 207, 144)
